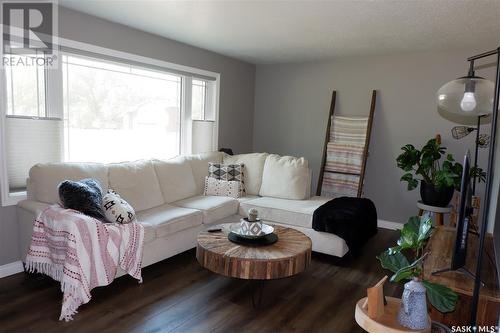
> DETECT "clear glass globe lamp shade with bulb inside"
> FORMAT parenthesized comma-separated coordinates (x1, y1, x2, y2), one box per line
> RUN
(437, 76, 495, 116)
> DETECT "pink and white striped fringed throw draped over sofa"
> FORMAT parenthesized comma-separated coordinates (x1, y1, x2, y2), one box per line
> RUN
(26, 205, 144, 321)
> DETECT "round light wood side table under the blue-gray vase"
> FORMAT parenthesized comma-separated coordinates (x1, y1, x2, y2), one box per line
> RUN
(354, 296, 431, 333)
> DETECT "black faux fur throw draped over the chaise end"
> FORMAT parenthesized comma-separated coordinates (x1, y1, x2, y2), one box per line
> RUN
(313, 197, 377, 254)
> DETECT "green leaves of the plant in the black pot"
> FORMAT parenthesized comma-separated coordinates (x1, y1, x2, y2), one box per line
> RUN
(396, 137, 486, 191)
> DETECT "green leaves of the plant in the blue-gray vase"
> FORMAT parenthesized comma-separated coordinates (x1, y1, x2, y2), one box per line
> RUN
(377, 216, 458, 313)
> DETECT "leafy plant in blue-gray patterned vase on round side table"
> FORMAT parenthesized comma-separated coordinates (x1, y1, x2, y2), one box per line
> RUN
(377, 216, 458, 329)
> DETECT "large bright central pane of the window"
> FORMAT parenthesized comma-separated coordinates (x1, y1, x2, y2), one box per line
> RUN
(63, 55, 181, 163)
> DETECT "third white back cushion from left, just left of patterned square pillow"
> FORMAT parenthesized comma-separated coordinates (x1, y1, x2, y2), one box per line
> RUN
(153, 157, 197, 203)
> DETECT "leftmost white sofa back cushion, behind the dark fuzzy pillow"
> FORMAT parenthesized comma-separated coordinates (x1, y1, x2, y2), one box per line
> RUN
(29, 163, 108, 203)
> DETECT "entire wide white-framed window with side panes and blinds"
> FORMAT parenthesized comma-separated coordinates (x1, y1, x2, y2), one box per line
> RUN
(0, 41, 219, 205)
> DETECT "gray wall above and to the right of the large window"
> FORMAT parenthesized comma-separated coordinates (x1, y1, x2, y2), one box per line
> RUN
(0, 8, 255, 265)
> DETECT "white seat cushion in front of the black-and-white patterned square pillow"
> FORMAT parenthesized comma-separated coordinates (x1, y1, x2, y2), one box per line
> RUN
(173, 195, 239, 224)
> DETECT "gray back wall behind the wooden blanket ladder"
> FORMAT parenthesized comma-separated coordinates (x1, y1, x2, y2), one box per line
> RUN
(253, 48, 492, 222)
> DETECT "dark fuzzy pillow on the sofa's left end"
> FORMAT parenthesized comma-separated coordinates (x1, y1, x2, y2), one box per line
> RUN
(59, 178, 104, 220)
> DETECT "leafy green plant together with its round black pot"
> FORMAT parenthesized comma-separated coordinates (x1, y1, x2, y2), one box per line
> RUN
(396, 136, 462, 207)
